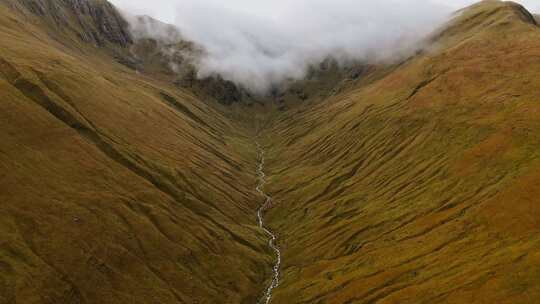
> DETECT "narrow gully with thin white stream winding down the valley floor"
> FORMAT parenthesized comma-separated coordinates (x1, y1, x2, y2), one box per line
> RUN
(256, 142, 281, 304)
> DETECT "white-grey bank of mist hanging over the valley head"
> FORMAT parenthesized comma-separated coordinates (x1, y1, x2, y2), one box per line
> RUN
(109, 0, 536, 93)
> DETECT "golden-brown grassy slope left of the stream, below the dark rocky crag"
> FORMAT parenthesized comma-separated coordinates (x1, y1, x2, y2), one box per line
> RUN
(0, 2, 272, 304)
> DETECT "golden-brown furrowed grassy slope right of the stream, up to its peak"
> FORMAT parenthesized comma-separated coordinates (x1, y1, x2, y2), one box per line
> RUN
(263, 1, 540, 303)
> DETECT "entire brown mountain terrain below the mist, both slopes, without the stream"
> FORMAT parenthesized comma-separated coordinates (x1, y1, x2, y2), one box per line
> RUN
(0, 0, 540, 304)
